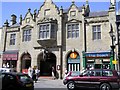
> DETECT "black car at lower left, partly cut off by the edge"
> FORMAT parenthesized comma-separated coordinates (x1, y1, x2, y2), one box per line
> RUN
(0, 72, 34, 90)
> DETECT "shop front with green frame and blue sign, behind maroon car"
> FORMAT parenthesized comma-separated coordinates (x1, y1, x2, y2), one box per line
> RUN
(83, 52, 114, 69)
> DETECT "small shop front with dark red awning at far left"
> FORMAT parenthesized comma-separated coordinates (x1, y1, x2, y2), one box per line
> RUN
(2, 51, 18, 69)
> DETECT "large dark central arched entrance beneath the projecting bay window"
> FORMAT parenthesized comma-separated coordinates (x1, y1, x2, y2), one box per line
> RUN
(38, 52, 56, 76)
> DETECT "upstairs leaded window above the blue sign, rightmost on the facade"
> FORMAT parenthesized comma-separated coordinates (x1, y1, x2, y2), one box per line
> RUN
(92, 25, 101, 40)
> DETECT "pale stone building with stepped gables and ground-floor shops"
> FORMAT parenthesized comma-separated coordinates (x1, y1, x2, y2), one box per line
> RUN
(0, 0, 116, 78)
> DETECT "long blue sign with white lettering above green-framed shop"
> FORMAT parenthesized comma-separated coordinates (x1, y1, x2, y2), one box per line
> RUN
(85, 52, 110, 58)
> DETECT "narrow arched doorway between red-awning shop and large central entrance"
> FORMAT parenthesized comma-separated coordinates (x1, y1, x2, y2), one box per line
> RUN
(21, 53, 31, 73)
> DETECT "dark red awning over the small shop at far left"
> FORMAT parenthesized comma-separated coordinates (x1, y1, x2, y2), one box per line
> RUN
(3, 51, 18, 60)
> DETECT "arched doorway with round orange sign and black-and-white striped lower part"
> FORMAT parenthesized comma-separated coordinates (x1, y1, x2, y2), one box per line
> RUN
(67, 51, 80, 73)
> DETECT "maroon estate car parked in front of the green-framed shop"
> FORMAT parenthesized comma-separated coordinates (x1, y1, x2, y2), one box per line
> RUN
(63, 69, 120, 90)
